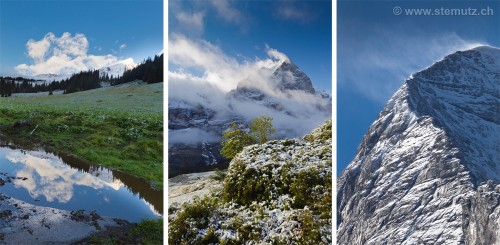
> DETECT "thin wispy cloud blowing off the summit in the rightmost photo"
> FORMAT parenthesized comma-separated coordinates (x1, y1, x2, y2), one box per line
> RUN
(338, 29, 484, 104)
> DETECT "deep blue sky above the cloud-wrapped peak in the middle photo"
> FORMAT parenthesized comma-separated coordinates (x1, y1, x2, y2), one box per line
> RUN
(169, 0, 332, 93)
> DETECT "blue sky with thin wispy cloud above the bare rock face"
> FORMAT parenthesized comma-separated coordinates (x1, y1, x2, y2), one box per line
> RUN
(337, 1, 500, 174)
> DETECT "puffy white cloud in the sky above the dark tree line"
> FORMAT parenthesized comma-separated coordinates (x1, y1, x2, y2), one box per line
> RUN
(15, 32, 126, 76)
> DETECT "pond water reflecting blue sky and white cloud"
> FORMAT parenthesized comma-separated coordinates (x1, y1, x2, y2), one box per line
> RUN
(0, 147, 163, 221)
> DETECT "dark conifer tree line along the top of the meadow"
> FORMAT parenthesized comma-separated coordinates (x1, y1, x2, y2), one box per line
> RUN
(0, 54, 163, 97)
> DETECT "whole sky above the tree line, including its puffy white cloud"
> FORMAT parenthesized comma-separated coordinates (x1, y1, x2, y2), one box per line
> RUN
(0, 0, 163, 75)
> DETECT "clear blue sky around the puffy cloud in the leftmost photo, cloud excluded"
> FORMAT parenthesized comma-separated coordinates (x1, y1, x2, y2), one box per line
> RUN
(0, 0, 163, 74)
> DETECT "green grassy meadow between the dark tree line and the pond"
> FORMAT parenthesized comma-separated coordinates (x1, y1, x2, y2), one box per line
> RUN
(0, 83, 163, 189)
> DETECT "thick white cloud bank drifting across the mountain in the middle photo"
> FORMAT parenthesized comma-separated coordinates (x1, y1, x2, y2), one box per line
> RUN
(168, 34, 331, 140)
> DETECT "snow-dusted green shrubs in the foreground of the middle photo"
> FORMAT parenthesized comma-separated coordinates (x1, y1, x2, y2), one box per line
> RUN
(169, 121, 332, 244)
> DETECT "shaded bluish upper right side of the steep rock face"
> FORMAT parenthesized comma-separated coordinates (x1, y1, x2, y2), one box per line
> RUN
(406, 46, 500, 184)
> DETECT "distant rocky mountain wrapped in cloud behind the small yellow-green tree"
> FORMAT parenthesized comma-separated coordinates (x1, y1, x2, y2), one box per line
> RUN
(168, 60, 331, 177)
